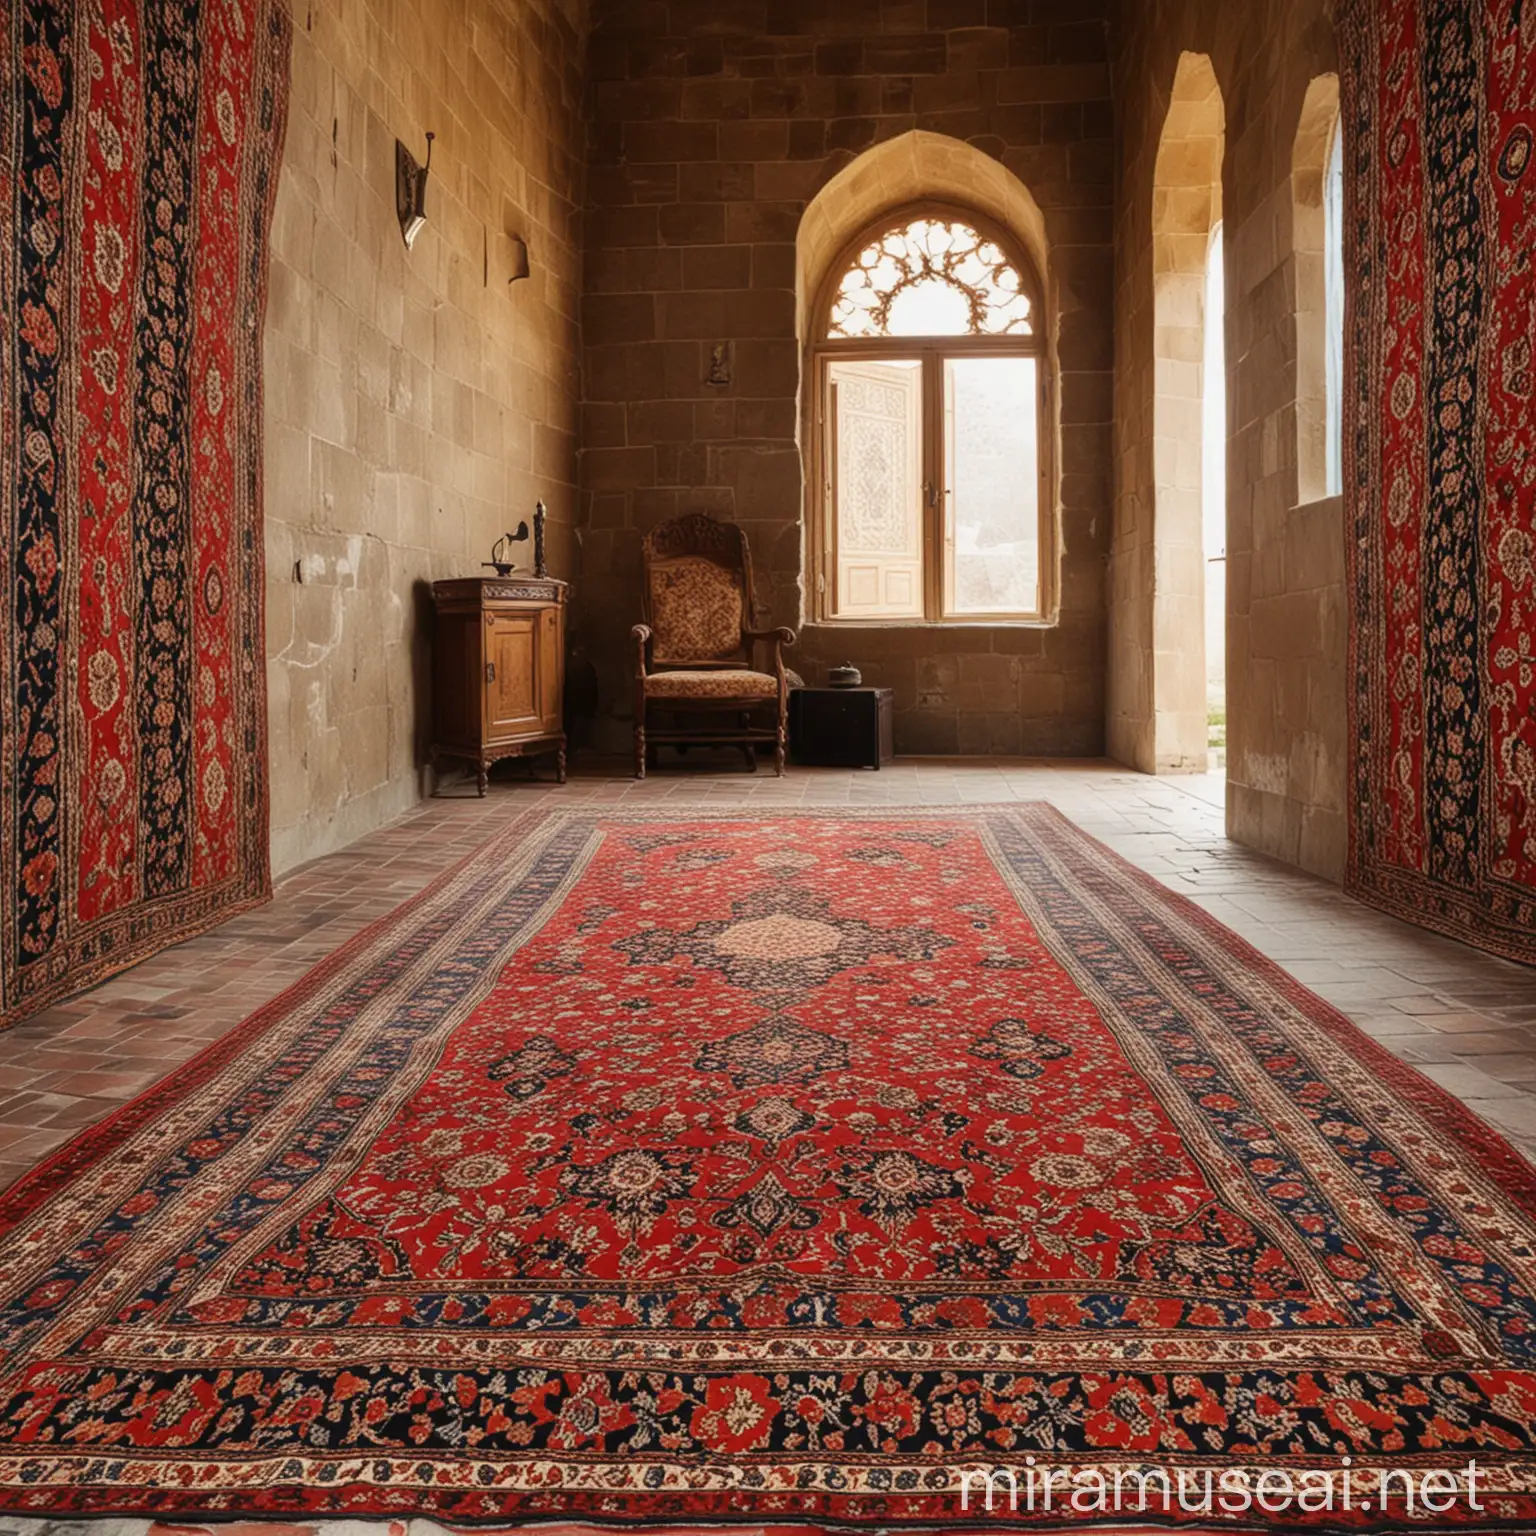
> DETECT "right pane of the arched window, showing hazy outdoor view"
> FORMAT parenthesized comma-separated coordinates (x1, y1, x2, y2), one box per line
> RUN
(945, 358, 1040, 616)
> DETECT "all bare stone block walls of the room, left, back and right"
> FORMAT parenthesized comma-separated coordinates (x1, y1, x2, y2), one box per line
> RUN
(266, 0, 1346, 876)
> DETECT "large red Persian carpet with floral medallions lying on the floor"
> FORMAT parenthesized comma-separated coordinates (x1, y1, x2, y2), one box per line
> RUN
(0, 806, 1536, 1531)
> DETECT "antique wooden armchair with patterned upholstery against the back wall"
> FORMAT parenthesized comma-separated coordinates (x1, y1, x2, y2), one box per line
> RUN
(631, 513, 794, 779)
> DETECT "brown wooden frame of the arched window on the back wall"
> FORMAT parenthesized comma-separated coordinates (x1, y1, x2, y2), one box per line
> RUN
(806, 203, 1058, 628)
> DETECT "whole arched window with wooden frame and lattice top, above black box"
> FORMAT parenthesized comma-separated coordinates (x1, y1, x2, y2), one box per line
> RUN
(813, 207, 1051, 624)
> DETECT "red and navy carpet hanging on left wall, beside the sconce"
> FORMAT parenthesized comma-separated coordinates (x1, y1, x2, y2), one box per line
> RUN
(0, 0, 290, 1025)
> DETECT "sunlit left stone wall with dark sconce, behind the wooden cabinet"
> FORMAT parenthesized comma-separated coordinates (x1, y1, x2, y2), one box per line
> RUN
(266, 0, 585, 871)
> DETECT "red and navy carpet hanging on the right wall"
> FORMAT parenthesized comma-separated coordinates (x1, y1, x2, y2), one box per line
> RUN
(1341, 0, 1536, 963)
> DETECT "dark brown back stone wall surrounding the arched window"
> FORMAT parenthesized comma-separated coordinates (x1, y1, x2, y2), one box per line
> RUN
(576, 0, 1114, 754)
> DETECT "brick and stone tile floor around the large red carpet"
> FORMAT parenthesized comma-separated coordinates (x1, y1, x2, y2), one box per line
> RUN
(9, 759, 1536, 1184)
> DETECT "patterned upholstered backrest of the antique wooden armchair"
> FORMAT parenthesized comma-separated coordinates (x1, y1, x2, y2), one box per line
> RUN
(644, 513, 753, 667)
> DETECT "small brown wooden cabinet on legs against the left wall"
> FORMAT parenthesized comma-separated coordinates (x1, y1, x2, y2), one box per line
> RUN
(432, 576, 565, 794)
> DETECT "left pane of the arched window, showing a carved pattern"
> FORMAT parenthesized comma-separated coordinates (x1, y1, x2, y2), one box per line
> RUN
(826, 358, 923, 619)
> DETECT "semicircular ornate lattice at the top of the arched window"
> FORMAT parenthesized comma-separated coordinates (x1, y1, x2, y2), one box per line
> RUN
(826, 217, 1034, 339)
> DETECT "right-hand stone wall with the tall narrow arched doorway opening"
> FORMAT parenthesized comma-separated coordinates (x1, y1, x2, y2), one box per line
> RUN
(1109, 0, 1347, 879)
